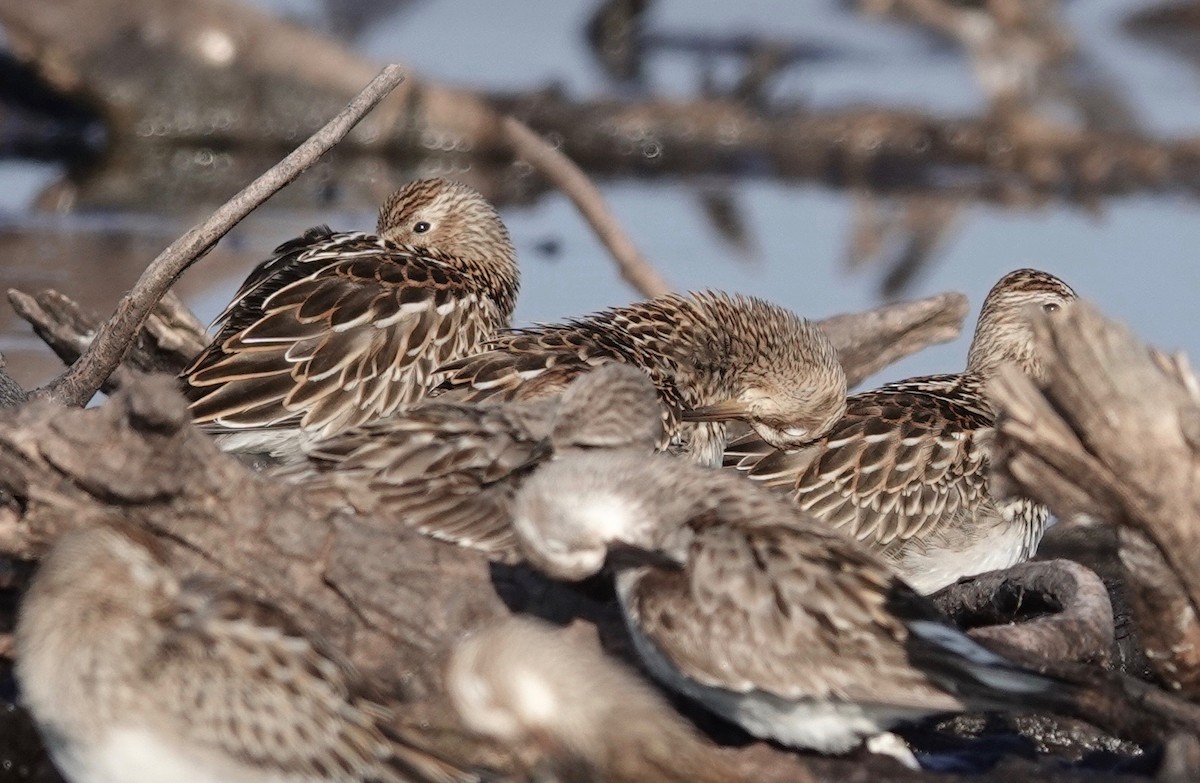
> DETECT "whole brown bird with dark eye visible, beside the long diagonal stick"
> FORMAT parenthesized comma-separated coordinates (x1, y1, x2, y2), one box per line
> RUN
(181, 179, 518, 453)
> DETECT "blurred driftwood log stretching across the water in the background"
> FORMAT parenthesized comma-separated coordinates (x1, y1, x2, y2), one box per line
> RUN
(0, 0, 1200, 203)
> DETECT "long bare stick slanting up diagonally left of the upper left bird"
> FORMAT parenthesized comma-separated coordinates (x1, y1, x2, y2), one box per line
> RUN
(34, 65, 404, 406)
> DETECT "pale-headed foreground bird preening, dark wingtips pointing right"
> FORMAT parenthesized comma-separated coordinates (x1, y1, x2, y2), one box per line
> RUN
(515, 452, 1055, 752)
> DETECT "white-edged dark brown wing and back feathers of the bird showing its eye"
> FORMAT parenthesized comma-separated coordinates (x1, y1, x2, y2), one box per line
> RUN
(182, 234, 503, 434)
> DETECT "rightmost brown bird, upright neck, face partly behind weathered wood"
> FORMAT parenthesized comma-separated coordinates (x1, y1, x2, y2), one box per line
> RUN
(726, 269, 1075, 593)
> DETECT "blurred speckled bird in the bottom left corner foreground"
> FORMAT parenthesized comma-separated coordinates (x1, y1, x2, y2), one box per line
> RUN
(16, 527, 478, 783)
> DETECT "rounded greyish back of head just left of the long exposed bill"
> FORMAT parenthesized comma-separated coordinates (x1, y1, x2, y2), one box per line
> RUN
(551, 363, 662, 452)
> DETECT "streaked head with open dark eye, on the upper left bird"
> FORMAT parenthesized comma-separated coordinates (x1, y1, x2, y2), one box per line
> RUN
(377, 179, 516, 265)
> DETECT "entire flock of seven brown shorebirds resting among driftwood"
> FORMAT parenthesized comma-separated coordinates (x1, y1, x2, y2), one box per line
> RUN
(16, 180, 1075, 783)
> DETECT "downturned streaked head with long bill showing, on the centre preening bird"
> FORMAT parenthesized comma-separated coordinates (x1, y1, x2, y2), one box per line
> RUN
(684, 298, 846, 449)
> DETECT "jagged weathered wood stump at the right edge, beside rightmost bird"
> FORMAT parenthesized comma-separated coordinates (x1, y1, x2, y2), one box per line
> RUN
(994, 303, 1200, 698)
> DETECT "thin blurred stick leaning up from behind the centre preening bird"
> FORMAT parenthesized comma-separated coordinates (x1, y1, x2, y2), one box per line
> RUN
(502, 116, 671, 297)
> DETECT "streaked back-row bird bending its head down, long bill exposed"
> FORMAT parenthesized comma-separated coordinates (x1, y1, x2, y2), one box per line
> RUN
(439, 292, 846, 465)
